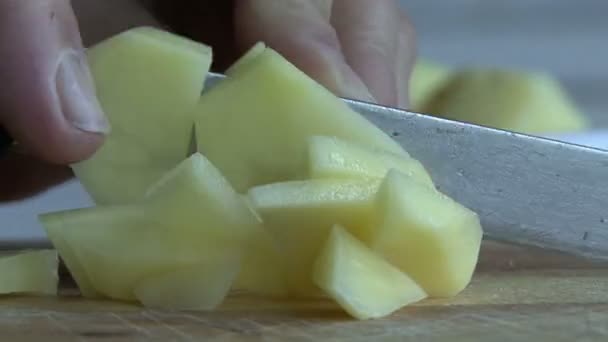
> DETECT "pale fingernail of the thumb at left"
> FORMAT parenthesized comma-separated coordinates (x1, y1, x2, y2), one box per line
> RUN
(55, 51, 110, 134)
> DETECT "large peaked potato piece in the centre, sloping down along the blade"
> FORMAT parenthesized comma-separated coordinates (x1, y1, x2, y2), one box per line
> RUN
(196, 48, 405, 192)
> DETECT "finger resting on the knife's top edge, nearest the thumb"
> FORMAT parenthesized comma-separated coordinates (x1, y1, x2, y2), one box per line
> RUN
(235, 0, 376, 102)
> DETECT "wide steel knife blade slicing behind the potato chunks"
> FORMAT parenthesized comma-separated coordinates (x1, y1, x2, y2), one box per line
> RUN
(1, 73, 608, 261)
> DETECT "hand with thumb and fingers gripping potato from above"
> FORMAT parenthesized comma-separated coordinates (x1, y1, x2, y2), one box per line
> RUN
(0, 0, 415, 200)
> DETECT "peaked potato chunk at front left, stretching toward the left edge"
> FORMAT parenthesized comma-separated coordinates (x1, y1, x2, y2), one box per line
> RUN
(43, 154, 259, 300)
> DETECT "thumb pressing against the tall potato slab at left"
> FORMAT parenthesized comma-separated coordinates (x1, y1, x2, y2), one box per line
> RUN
(0, 0, 109, 163)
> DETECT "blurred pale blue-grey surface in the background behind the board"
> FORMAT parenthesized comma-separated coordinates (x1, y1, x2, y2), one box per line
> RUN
(0, 0, 608, 244)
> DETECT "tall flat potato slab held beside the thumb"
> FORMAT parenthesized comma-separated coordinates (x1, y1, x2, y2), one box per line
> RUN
(73, 27, 212, 204)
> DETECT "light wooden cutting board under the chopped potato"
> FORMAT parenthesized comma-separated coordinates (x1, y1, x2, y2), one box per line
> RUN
(0, 242, 608, 342)
